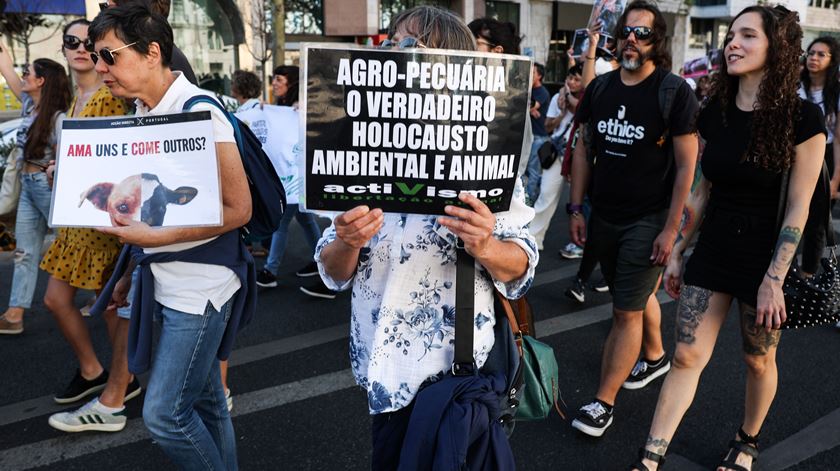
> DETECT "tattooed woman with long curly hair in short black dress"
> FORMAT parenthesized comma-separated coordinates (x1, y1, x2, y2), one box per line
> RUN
(634, 6, 825, 471)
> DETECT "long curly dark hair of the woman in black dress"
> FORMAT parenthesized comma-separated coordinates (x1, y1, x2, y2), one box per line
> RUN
(709, 5, 802, 172)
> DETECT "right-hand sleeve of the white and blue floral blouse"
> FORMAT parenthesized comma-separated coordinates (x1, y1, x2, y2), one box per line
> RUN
(493, 178, 540, 299)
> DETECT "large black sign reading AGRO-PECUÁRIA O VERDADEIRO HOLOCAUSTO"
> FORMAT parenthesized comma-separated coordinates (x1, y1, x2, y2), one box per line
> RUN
(301, 45, 531, 214)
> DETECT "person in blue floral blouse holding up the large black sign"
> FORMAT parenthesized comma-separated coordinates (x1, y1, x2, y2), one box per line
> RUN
(316, 6, 539, 470)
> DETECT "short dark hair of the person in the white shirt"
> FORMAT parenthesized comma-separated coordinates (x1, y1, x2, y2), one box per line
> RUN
(88, 2, 174, 67)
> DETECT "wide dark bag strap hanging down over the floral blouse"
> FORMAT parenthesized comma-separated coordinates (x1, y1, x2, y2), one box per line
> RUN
(452, 238, 476, 376)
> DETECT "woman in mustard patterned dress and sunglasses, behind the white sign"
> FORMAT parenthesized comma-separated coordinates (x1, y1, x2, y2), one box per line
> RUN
(41, 19, 140, 432)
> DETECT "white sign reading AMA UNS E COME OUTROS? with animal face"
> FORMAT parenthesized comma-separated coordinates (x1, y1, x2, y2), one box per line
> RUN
(50, 111, 222, 227)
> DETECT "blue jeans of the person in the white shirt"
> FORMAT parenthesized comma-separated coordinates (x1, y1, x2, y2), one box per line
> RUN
(143, 299, 237, 470)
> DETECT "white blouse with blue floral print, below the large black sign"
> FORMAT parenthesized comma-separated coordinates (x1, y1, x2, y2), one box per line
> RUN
(315, 179, 539, 414)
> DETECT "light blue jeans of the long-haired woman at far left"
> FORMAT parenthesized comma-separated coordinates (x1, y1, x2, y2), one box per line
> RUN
(9, 172, 52, 309)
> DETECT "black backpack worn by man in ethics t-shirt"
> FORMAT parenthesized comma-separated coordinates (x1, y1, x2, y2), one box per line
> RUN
(586, 69, 684, 186)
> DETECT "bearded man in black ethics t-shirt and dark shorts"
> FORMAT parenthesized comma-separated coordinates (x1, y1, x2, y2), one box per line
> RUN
(567, 1, 698, 437)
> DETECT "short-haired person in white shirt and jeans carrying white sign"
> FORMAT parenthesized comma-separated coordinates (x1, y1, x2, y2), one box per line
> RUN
(89, 4, 251, 470)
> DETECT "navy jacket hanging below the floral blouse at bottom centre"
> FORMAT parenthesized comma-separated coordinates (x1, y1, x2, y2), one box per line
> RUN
(399, 374, 516, 471)
